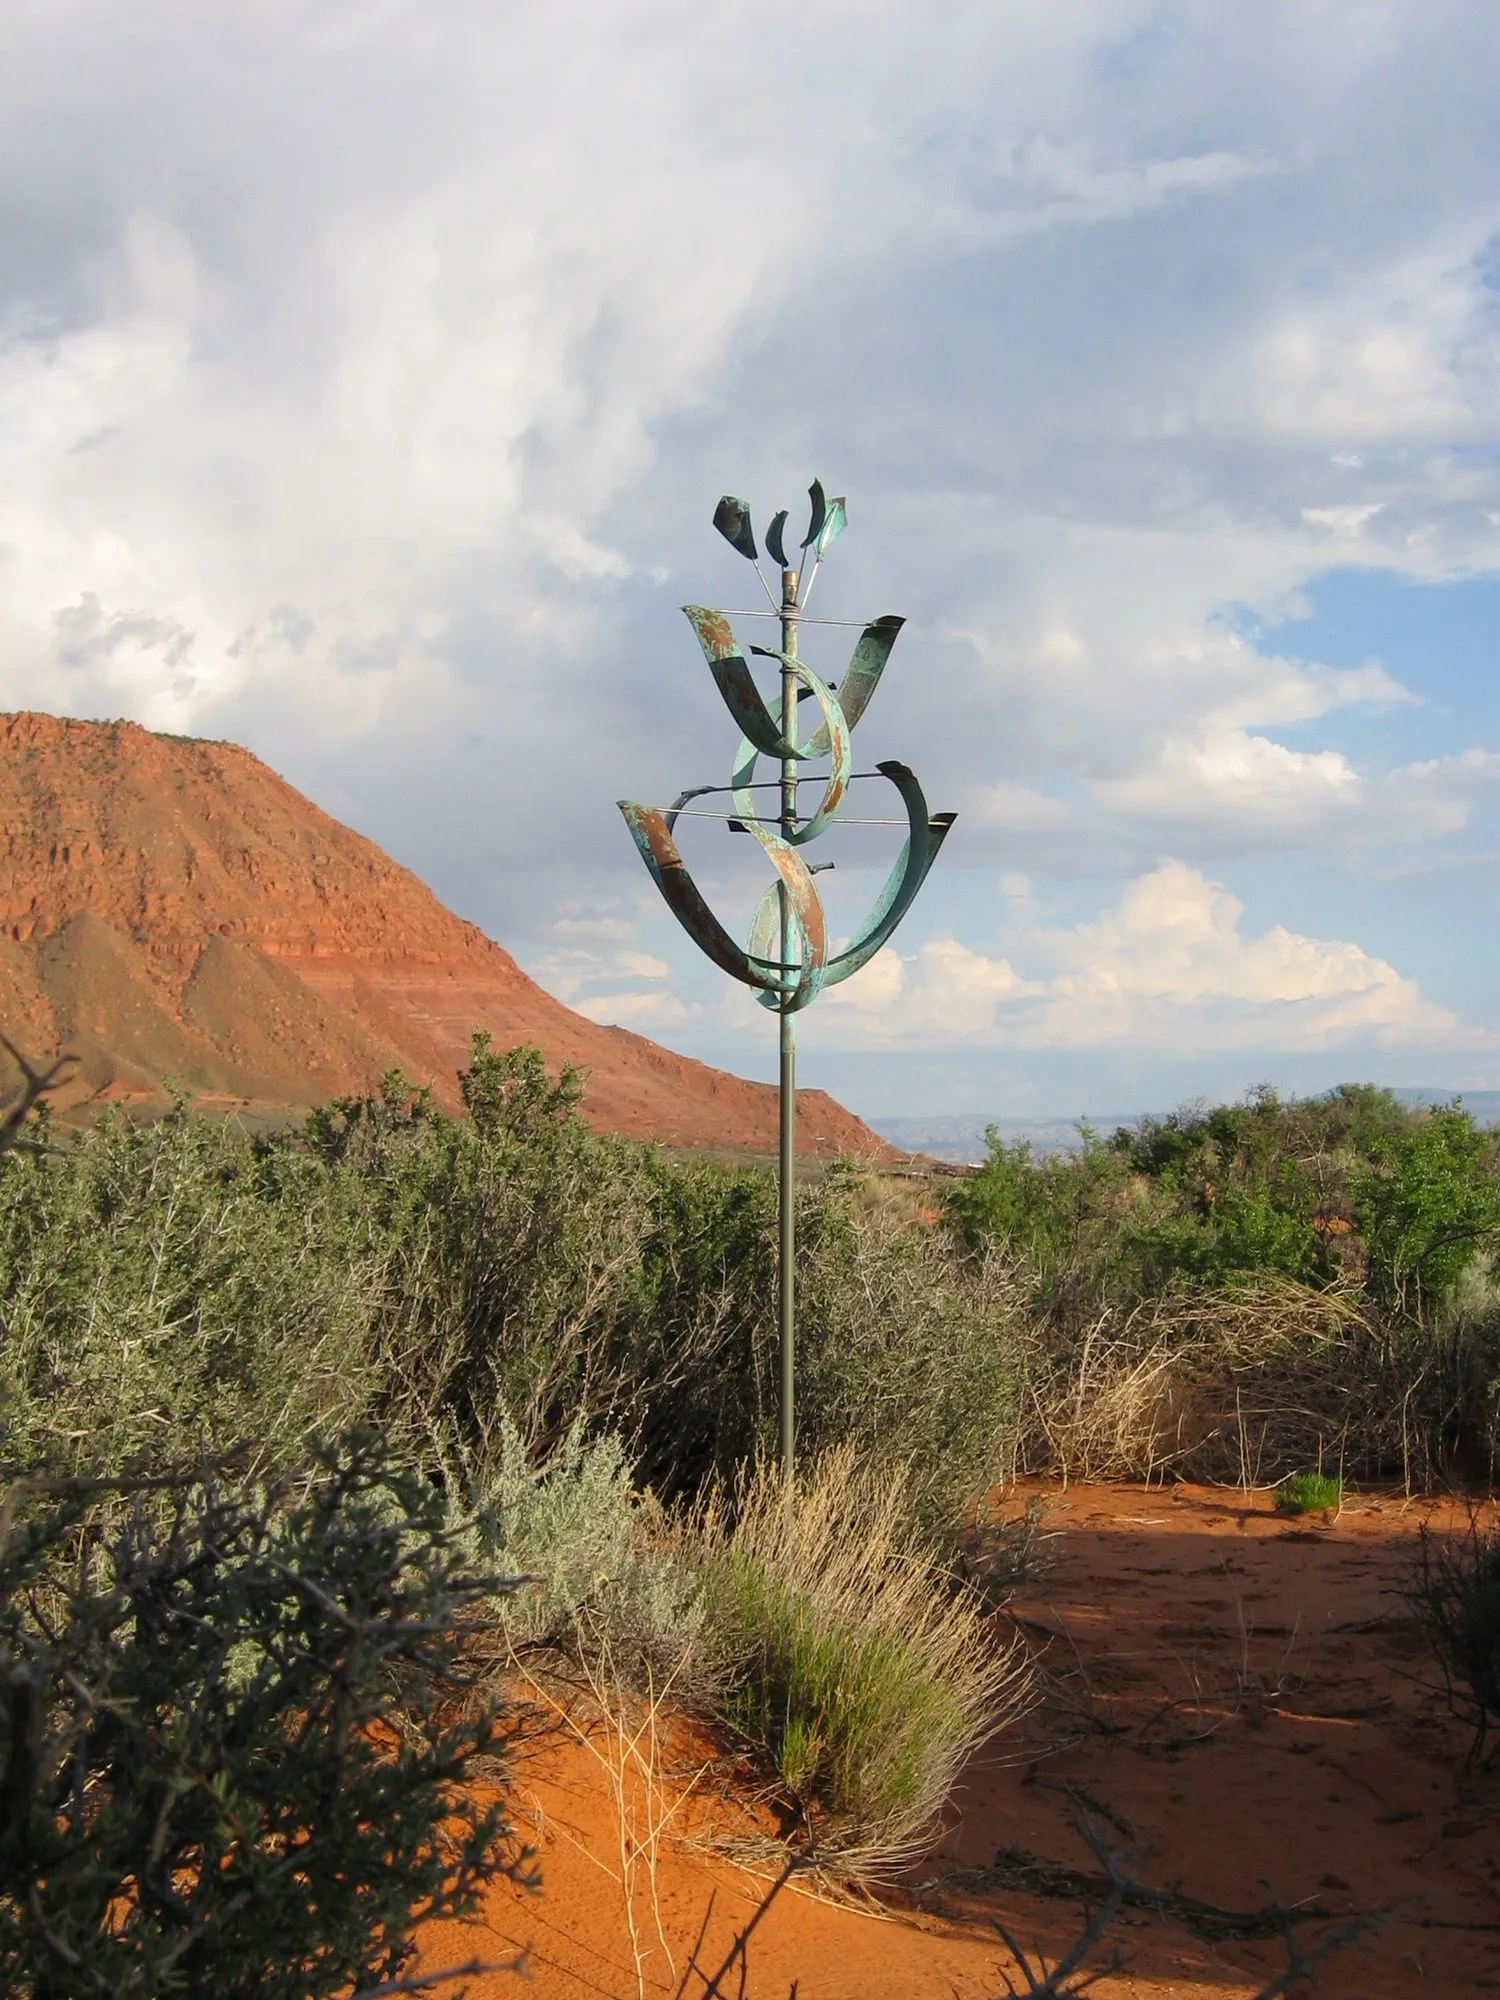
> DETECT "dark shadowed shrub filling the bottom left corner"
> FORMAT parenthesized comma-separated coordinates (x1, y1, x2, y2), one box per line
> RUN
(0, 1436, 526, 2000)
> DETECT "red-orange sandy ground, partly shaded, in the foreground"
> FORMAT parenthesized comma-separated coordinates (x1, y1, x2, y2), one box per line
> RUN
(424, 1486, 1500, 2000)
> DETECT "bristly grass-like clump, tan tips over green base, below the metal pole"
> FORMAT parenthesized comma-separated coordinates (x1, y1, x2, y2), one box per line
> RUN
(684, 1446, 1030, 1874)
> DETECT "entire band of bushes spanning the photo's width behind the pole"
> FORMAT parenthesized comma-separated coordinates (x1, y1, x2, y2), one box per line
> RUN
(11, 1036, 1500, 1532)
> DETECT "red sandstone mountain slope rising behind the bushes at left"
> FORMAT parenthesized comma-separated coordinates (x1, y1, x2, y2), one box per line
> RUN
(0, 714, 894, 1158)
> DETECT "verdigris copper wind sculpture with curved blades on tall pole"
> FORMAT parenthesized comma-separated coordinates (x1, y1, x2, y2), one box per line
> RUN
(620, 480, 954, 1474)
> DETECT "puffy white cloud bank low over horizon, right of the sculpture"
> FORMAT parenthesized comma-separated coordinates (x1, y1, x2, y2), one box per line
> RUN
(826, 862, 1500, 1056)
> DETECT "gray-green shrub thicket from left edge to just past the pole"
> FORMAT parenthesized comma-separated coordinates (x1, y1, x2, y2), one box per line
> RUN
(0, 1036, 1014, 1492)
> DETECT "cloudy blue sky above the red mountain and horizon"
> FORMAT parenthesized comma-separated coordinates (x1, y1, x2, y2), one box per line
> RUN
(0, 0, 1500, 1116)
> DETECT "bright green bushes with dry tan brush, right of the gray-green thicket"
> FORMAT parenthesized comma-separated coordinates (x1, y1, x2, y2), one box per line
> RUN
(946, 1084, 1500, 1484)
